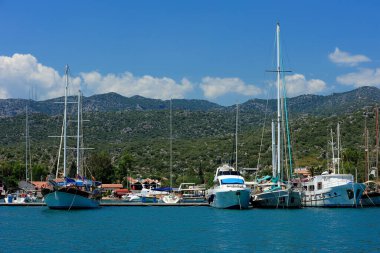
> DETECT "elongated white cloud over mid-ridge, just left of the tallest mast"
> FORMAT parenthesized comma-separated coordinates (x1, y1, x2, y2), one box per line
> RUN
(200, 77, 261, 99)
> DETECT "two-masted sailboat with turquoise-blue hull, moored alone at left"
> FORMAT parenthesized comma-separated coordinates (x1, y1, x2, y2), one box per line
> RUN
(42, 66, 101, 210)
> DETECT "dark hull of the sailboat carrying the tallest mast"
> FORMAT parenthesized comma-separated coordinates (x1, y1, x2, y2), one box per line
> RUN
(252, 189, 302, 208)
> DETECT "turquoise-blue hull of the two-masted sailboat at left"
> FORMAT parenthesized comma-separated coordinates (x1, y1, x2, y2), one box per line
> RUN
(44, 191, 99, 210)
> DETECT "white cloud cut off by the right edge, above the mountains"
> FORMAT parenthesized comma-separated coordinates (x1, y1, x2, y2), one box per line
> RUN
(336, 68, 380, 87)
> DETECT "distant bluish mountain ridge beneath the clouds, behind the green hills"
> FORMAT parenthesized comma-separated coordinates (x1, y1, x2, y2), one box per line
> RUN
(0, 86, 380, 117)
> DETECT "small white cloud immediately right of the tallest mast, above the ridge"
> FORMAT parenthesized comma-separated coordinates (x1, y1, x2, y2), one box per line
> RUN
(285, 74, 326, 96)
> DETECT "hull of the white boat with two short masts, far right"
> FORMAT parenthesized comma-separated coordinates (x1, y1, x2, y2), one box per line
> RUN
(302, 182, 365, 207)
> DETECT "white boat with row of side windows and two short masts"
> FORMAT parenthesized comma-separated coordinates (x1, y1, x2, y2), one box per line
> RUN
(302, 124, 365, 207)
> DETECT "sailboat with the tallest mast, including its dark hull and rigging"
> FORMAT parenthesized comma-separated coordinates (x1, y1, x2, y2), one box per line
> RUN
(252, 23, 301, 208)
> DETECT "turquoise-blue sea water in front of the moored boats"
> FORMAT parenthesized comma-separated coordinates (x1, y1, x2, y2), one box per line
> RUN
(0, 206, 380, 252)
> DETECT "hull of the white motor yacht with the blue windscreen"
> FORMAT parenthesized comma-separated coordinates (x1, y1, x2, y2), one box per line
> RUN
(208, 188, 251, 209)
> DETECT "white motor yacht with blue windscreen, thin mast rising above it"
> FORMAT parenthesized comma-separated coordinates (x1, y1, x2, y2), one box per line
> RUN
(206, 106, 251, 209)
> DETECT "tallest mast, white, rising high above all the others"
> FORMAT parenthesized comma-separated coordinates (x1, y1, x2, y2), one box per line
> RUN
(276, 23, 281, 182)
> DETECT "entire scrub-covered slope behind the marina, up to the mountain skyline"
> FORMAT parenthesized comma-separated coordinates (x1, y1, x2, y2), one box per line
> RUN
(0, 87, 380, 188)
